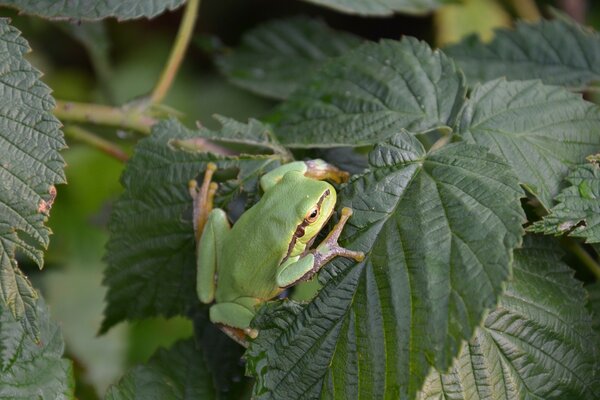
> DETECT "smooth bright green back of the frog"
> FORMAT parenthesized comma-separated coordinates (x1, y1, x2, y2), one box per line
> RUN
(216, 174, 328, 302)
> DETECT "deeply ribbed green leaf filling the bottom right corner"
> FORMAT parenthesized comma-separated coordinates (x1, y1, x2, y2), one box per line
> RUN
(419, 237, 600, 400)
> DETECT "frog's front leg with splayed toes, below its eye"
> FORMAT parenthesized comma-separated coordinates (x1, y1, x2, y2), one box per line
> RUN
(276, 207, 365, 288)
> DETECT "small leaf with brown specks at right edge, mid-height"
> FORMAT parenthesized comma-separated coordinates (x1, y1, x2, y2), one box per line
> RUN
(529, 164, 600, 243)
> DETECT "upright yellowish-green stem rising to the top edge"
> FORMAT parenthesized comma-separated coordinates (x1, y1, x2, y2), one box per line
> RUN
(150, 0, 200, 103)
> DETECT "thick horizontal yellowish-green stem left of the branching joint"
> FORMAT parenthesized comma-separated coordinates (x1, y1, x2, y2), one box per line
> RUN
(54, 100, 157, 134)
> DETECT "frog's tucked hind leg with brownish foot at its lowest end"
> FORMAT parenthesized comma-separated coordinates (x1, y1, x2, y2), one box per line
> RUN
(209, 298, 258, 347)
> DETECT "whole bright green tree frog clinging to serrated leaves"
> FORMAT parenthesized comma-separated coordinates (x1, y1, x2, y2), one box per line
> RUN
(189, 160, 364, 347)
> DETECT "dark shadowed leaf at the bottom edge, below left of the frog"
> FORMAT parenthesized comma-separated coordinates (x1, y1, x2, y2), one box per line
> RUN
(105, 339, 216, 400)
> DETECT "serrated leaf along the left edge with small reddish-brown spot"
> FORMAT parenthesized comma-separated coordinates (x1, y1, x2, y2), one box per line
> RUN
(0, 18, 65, 336)
